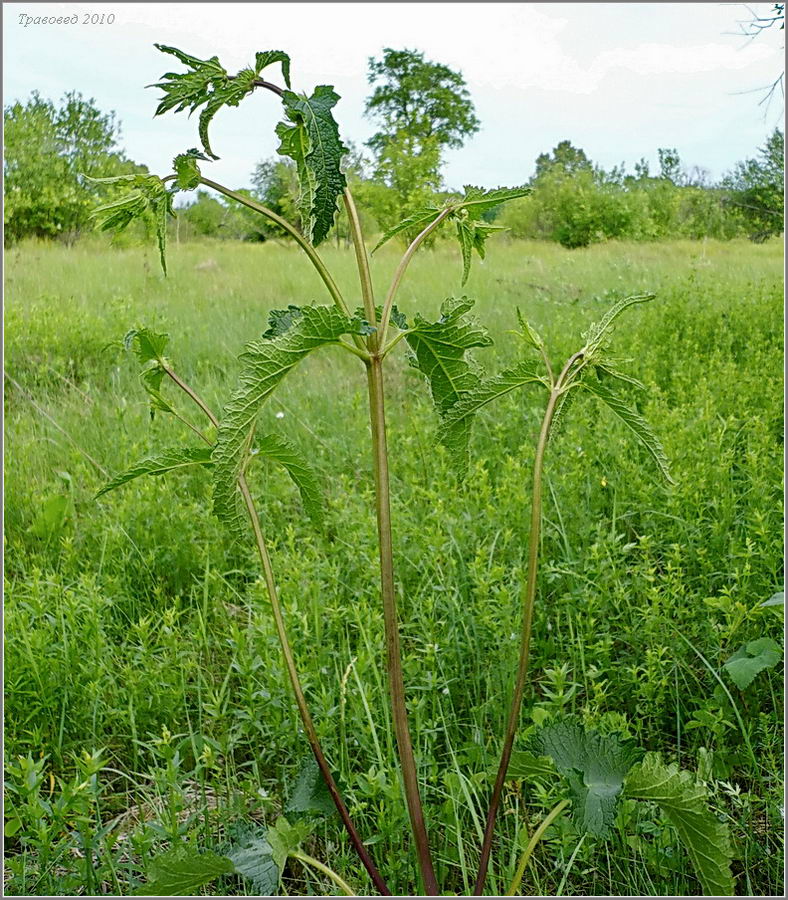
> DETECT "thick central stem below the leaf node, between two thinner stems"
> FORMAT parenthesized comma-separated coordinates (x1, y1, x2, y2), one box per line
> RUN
(367, 357, 439, 896)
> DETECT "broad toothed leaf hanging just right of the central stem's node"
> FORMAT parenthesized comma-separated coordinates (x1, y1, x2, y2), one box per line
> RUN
(405, 297, 492, 447)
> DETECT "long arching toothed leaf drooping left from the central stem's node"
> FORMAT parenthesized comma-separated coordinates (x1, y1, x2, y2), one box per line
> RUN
(213, 306, 360, 535)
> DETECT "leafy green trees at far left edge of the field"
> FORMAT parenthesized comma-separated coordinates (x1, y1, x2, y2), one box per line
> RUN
(3, 92, 146, 243)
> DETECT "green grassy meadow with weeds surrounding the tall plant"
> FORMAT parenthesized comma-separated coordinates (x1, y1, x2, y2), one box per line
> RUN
(5, 240, 783, 895)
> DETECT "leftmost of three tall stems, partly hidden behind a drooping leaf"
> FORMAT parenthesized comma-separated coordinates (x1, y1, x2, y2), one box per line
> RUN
(165, 367, 391, 896)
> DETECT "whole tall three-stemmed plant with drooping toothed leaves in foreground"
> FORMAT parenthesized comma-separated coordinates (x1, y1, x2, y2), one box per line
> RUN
(89, 47, 736, 895)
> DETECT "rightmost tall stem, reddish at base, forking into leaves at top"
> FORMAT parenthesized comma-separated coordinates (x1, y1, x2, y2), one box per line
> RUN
(474, 351, 582, 897)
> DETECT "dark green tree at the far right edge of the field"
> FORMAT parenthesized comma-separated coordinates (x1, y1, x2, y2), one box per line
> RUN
(723, 128, 785, 241)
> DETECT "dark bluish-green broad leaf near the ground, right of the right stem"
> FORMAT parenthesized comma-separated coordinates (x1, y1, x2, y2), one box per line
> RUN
(533, 722, 636, 837)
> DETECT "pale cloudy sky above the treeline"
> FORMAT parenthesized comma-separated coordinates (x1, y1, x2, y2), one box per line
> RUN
(3, 2, 784, 188)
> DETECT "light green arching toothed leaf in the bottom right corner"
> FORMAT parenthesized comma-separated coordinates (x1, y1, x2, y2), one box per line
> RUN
(624, 753, 734, 897)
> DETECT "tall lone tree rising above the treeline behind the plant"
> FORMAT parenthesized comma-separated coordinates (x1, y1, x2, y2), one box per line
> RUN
(366, 48, 479, 234)
